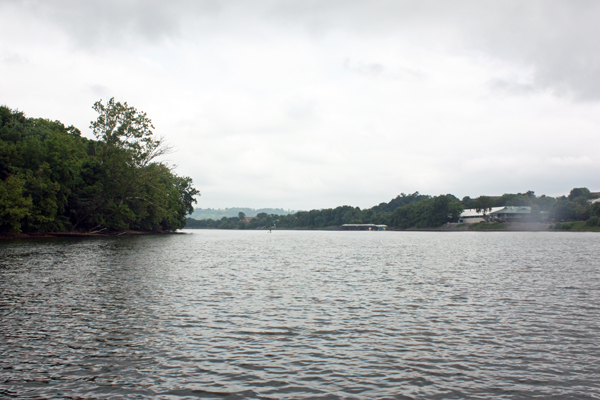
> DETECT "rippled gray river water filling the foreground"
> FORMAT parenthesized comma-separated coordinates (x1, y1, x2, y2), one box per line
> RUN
(0, 230, 600, 399)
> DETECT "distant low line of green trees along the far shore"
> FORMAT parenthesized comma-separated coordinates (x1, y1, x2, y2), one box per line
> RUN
(187, 188, 600, 229)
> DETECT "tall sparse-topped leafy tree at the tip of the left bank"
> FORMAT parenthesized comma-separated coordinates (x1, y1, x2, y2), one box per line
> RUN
(84, 98, 199, 230)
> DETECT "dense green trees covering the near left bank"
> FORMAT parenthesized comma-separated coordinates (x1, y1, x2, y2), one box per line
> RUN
(0, 99, 198, 232)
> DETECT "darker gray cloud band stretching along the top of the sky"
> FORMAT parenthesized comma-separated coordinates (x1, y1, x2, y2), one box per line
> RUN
(10, 0, 600, 100)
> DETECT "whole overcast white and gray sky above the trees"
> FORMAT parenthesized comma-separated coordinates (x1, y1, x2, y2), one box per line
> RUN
(0, 0, 600, 210)
